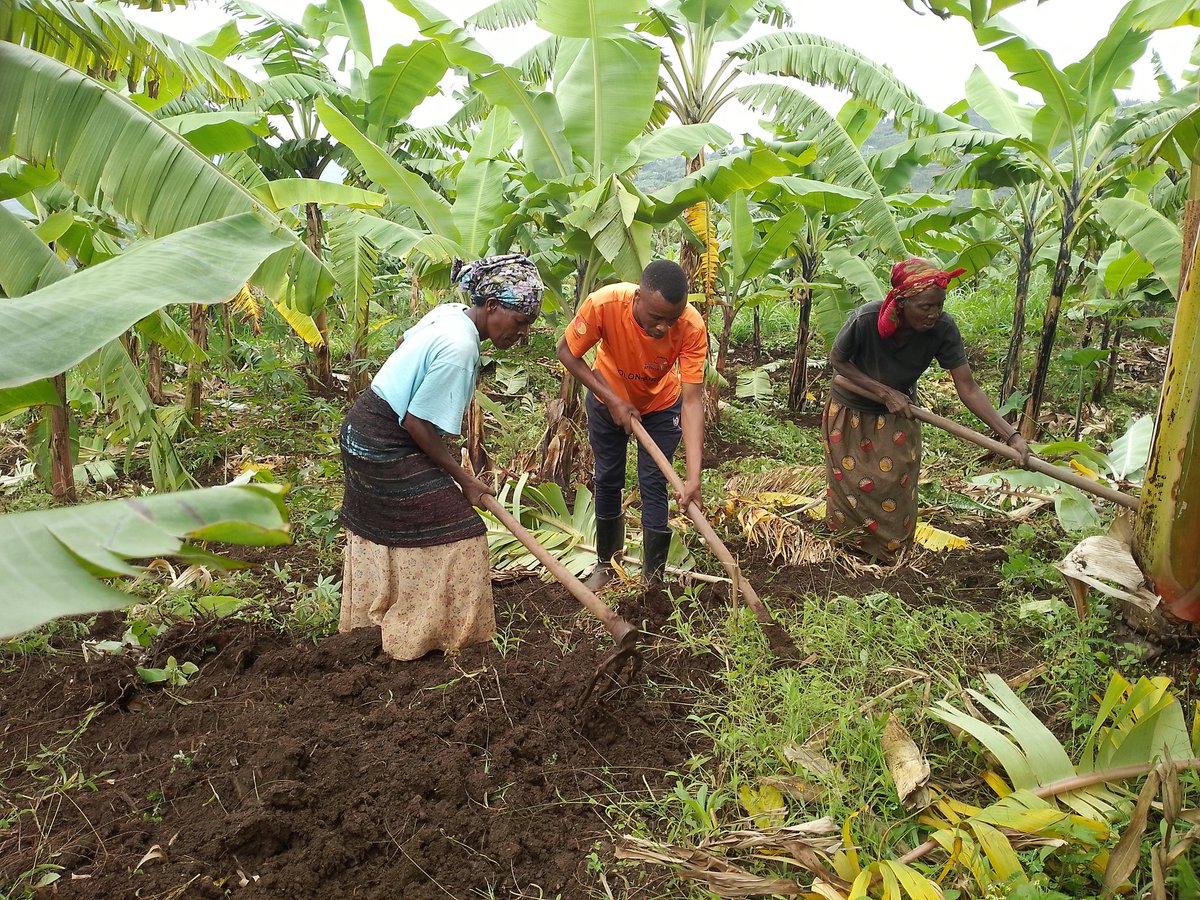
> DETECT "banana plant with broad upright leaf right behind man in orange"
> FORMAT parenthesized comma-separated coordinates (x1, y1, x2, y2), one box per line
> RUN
(392, 0, 811, 484)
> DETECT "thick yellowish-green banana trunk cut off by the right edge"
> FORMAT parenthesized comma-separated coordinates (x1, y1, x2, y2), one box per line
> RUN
(1133, 183, 1200, 622)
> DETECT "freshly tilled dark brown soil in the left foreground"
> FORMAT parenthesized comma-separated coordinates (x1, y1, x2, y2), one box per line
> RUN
(0, 581, 719, 899)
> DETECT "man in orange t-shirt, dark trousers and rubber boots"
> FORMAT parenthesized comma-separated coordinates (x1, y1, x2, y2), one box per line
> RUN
(558, 259, 708, 590)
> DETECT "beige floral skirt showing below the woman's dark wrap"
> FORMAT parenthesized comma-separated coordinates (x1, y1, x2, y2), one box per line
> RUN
(337, 532, 496, 660)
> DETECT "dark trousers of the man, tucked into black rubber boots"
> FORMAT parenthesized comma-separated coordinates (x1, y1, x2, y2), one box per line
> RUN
(586, 391, 683, 532)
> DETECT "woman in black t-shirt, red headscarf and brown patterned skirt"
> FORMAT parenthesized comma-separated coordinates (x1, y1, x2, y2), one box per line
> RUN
(821, 258, 1030, 562)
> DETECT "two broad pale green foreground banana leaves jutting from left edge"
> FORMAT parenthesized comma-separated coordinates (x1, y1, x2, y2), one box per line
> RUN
(0, 212, 294, 636)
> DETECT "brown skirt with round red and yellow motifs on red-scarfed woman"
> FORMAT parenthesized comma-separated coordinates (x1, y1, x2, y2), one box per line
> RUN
(821, 398, 920, 562)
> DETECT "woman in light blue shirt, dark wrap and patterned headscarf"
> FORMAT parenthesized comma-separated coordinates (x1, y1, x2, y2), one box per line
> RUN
(338, 254, 542, 659)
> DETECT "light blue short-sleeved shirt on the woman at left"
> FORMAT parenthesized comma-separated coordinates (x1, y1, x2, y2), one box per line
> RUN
(371, 304, 479, 434)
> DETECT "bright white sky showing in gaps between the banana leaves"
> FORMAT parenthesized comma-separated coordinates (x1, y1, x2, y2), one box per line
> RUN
(126, 0, 1200, 134)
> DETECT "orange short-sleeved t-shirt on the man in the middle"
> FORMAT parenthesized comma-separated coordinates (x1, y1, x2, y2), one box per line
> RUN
(566, 283, 708, 413)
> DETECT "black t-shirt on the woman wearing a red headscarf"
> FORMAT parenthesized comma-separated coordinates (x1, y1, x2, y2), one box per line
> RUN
(833, 300, 967, 413)
